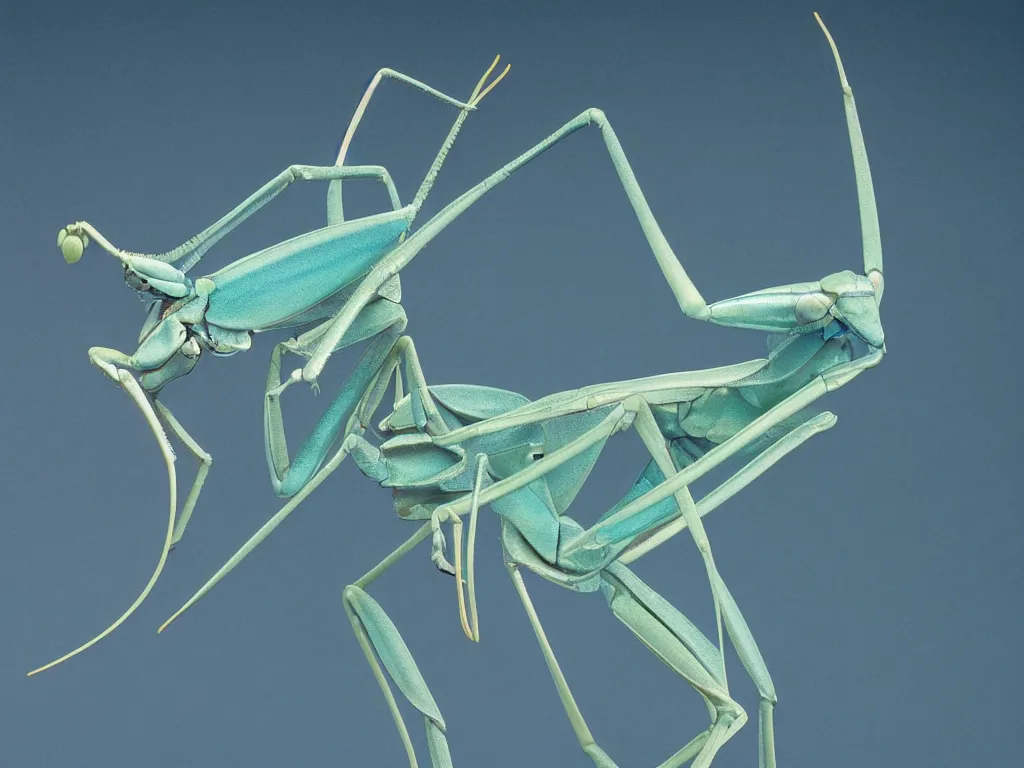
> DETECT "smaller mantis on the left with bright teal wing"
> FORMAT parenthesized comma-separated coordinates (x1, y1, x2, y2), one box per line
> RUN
(29, 57, 509, 676)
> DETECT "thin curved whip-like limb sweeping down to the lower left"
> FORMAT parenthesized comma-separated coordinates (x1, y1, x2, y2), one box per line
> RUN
(29, 347, 177, 677)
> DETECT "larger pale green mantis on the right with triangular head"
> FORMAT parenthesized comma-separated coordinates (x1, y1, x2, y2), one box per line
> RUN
(34, 12, 885, 768)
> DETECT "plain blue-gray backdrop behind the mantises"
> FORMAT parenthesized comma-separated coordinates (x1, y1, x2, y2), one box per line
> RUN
(0, 0, 1024, 768)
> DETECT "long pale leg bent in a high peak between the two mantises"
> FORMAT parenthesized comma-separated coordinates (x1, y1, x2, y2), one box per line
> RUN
(302, 109, 710, 382)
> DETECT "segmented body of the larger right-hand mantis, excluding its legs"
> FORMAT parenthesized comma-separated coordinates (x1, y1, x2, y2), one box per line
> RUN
(353, 328, 854, 591)
